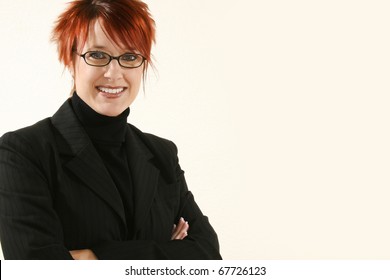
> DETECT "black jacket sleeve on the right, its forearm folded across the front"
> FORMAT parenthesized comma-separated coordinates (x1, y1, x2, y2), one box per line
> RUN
(92, 142, 221, 260)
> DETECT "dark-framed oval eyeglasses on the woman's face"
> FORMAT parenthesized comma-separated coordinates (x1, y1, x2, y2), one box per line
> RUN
(75, 51, 145, 68)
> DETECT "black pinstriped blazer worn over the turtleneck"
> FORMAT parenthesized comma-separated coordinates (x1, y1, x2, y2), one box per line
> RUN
(0, 100, 221, 259)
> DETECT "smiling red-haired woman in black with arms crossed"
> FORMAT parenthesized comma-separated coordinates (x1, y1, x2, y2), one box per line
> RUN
(0, 0, 221, 259)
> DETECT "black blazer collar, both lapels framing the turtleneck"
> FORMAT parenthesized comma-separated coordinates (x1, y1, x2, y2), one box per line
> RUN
(51, 100, 160, 233)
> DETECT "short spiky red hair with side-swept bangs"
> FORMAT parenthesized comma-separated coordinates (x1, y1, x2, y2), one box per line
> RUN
(52, 0, 155, 69)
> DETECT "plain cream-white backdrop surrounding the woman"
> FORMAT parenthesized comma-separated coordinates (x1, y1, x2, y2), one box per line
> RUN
(0, 0, 390, 259)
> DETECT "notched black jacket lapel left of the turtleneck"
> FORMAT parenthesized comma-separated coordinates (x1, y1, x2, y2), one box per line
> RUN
(52, 100, 126, 224)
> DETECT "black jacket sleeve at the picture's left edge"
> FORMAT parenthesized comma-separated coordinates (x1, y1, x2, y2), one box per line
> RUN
(0, 132, 72, 259)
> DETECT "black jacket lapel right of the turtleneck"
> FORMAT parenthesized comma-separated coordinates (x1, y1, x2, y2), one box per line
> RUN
(126, 126, 160, 237)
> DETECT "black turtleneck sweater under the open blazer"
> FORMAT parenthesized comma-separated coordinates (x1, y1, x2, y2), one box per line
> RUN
(71, 92, 134, 237)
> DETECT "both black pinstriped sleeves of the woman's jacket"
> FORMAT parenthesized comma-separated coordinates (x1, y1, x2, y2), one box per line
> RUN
(0, 132, 221, 259)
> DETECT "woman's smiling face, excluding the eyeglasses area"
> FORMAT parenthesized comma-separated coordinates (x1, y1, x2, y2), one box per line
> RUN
(69, 21, 143, 117)
